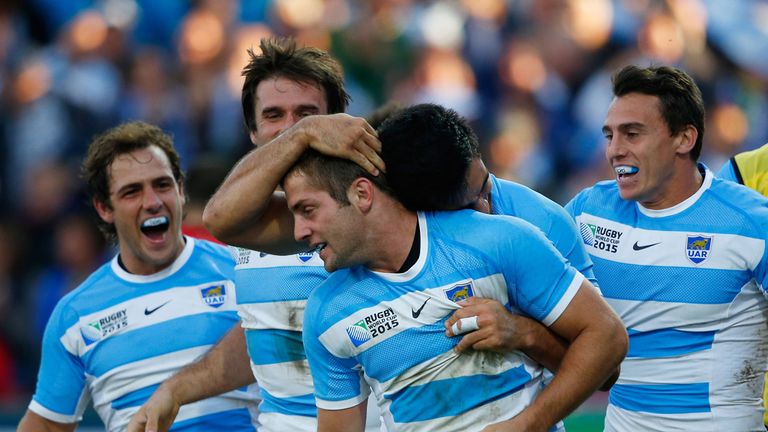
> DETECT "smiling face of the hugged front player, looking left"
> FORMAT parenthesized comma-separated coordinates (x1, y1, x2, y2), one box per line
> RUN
(283, 171, 365, 272)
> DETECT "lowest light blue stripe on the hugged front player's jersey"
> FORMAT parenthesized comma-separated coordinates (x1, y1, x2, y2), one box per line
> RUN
(384, 365, 531, 423)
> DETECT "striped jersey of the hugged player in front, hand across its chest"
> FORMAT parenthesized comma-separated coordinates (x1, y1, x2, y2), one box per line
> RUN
(304, 210, 584, 431)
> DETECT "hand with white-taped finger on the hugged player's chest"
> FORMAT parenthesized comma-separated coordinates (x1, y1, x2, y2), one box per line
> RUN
(445, 297, 530, 353)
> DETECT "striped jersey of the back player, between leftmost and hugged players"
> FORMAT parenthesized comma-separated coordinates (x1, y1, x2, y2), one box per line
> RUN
(232, 248, 328, 432)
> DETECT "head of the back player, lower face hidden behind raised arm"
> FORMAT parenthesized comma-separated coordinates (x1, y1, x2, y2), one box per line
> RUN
(241, 38, 349, 145)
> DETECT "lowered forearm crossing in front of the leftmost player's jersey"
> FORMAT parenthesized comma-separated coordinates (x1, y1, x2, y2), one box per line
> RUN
(160, 324, 256, 405)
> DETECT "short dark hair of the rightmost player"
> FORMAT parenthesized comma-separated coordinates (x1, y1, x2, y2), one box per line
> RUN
(612, 65, 705, 161)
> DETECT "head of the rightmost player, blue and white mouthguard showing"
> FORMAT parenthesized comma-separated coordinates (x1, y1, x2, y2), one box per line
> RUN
(603, 66, 704, 208)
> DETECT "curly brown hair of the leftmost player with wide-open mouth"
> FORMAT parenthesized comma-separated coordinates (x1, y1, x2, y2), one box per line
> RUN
(80, 121, 184, 240)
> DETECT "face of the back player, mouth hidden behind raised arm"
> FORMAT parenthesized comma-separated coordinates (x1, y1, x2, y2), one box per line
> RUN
(251, 77, 328, 146)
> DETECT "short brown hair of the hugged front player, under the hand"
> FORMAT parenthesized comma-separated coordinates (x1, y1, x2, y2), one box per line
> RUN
(283, 149, 393, 206)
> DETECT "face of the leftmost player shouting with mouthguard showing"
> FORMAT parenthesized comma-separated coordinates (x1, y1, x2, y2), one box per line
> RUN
(94, 146, 184, 275)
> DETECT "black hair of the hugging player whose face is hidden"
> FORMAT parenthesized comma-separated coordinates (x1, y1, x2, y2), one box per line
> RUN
(378, 104, 480, 211)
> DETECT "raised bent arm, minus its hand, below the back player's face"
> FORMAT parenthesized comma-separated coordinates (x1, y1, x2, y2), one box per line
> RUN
(203, 127, 308, 253)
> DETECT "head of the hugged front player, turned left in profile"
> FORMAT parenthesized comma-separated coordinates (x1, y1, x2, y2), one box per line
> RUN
(282, 150, 392, 271)
